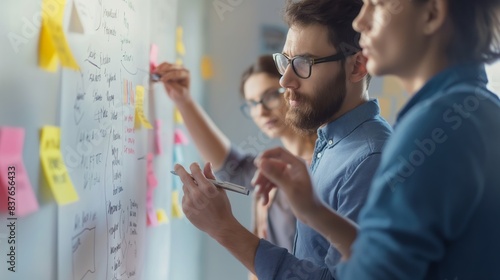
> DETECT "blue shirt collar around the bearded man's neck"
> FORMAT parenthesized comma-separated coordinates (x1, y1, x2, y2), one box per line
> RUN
(318, 99, 380, 145)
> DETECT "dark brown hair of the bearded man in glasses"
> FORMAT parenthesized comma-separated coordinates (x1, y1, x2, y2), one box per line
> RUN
(284, 0, 371, 87)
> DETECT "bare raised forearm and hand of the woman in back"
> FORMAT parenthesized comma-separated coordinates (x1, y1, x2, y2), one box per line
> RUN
(154, 62, 230, 170)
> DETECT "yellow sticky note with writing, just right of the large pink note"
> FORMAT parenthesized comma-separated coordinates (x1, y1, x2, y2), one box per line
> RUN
(40, 126, 78, 205)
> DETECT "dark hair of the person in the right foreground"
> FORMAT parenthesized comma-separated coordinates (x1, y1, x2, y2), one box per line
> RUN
(418, 0, 500, 63)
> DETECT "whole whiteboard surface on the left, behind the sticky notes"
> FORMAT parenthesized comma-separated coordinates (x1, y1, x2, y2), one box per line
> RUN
(0, 0, 177, 280)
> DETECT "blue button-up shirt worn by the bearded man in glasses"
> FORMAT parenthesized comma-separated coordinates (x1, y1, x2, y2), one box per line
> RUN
(255, 100, 391, 280)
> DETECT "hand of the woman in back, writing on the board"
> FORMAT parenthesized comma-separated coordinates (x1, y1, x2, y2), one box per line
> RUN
(153, 62, 191, 105)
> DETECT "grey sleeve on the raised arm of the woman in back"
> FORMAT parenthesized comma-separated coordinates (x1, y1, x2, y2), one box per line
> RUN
(215, 146, 256, 190)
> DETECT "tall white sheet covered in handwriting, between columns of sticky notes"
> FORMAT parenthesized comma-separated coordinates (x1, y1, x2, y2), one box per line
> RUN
(58, 0, 149, 280)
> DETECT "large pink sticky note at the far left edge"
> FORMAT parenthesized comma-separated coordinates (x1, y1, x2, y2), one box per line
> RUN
(0, 127, 38, 217)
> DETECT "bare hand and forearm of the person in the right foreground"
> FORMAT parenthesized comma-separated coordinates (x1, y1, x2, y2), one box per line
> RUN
(254, 148, 357, 259)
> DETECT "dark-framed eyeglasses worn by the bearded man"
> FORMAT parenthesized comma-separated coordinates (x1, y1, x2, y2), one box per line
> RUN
(273, 52, 347, 79)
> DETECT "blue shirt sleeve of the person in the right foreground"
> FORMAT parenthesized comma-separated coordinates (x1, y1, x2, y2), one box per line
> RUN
(336, 97, 485, 280)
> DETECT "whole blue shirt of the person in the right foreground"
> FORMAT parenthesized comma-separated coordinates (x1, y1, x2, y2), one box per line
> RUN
(334, 64, 500, 280)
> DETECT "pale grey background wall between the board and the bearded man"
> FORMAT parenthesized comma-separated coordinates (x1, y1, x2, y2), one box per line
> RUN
(202, 0, 284, 280)
